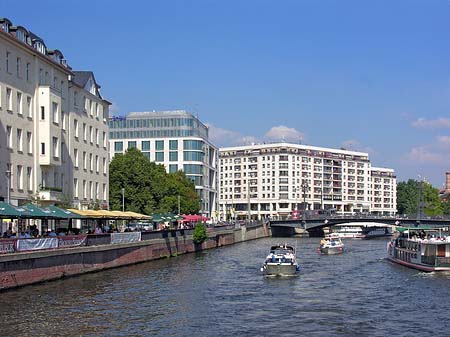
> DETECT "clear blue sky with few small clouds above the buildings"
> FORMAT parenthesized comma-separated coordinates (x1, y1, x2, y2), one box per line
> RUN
(4, 0, 450, 187)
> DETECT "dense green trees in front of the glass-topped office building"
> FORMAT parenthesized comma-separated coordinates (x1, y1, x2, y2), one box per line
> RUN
(109, 148, 200, 214)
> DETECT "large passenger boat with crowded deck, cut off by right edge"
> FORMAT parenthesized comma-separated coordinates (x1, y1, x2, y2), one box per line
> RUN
(387, 227, 450, 272)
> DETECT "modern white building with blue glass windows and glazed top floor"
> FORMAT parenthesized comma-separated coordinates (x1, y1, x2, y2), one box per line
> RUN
(109, 110, 218, 217)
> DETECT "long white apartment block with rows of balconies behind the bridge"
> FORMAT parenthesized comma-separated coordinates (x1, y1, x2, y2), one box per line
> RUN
(219, 143, 397, 220)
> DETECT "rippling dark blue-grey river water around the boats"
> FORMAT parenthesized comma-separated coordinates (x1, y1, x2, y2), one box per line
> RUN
(0, 238, 450, 336)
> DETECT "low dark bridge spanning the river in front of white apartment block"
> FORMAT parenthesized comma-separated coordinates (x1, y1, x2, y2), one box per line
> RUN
(269, 215, 450, 236)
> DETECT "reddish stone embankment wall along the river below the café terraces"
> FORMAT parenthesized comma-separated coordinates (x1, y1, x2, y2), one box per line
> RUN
(0, 225, 270, 290)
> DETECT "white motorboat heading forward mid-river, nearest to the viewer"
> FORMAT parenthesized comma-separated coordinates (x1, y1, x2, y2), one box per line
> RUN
(261, 244, 300, 276)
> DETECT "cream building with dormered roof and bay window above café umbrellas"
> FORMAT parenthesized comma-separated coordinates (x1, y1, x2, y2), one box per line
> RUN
(0, 18, 110, 209)
